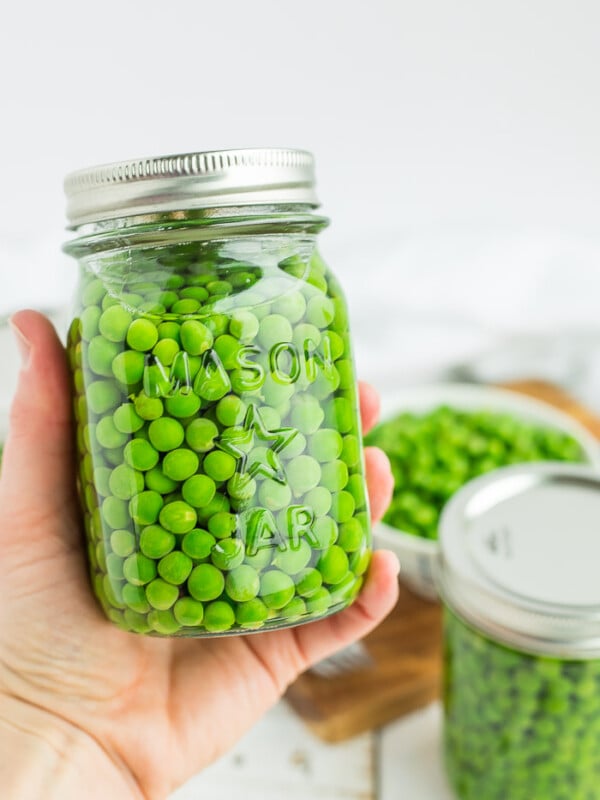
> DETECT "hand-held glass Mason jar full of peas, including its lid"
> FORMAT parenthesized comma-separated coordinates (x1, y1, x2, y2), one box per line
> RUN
(66, 150, 371, 636)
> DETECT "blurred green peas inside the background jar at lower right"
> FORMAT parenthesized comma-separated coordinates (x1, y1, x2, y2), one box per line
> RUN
(444, 610, 600, 800)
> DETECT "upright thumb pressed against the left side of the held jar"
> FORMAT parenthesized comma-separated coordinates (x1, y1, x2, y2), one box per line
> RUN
(0, 311, 74, 517)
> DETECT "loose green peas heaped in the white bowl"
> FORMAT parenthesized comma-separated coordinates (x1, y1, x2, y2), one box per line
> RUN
(365, 406, 584, 539)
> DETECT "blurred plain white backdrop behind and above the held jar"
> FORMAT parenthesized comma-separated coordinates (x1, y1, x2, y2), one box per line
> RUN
(0, 0, 600, 407)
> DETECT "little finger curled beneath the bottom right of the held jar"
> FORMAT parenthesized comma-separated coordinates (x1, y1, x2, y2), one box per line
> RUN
(294, 550, 400, 668)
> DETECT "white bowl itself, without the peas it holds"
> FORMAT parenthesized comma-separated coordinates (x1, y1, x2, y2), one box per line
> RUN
(373, 383, 600, 600)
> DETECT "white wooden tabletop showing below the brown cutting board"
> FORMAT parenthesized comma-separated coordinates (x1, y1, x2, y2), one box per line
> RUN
(170, 701, 453, 800)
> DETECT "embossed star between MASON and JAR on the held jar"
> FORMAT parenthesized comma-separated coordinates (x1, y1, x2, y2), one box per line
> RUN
(216, 403, 298, 484)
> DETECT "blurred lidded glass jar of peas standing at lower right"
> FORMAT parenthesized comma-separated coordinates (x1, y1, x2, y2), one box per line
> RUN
(439, 463, 600, 800)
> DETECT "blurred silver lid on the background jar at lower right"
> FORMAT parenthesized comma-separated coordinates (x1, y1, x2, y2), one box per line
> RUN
(438, 463, 600, 658)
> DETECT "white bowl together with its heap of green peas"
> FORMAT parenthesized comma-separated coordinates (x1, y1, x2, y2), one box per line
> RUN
(366, 384, 600, 599)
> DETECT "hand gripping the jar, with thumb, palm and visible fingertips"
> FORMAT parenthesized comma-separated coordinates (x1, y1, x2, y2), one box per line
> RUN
(0, 311, 398, 800)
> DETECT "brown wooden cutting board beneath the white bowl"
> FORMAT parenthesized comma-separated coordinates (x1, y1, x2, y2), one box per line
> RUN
(286, 381, 600, 742)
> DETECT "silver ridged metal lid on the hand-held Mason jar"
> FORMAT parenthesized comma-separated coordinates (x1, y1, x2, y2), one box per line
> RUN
(65, 147, 319, 227)
